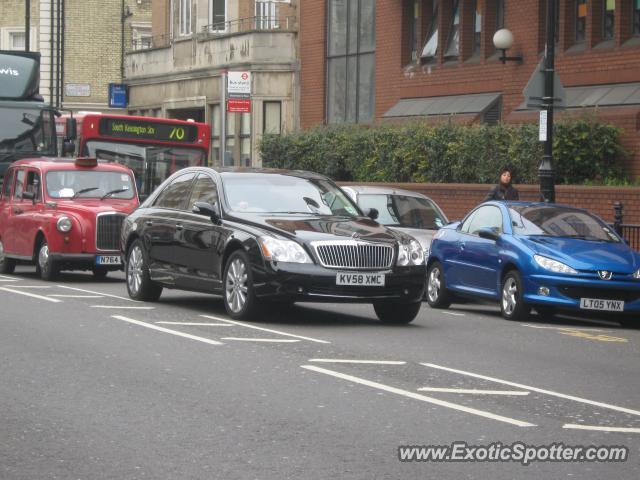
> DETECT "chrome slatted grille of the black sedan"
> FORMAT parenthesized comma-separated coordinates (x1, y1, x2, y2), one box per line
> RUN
(312, 240, 393, 270)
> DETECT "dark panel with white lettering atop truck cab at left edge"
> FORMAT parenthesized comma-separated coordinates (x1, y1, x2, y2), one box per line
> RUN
(0, 50, 40, 100)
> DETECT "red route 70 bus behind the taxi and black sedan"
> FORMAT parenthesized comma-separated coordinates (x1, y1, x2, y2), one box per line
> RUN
(59, 113, 211, 197)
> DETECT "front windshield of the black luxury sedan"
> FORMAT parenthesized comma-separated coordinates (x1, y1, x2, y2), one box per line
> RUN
(222, 172, 362, 217)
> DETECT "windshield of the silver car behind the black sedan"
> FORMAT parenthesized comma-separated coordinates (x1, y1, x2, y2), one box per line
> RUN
(358, 194, 447, 230)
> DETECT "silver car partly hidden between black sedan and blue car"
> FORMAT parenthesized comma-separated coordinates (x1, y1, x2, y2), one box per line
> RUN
(342, 185, 449, 258)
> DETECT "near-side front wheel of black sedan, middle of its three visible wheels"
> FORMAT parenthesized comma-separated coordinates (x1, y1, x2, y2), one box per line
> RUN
(224, 250, 258, 320)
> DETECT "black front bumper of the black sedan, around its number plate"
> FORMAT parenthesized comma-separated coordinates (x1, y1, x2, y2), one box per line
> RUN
(253, 263, 426, 303)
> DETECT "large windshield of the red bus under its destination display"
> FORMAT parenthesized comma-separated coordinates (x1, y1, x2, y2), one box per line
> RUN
(83, 140, 206, 195)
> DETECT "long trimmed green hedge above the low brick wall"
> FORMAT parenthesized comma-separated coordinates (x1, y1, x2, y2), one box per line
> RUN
(260, 119, 626, 184)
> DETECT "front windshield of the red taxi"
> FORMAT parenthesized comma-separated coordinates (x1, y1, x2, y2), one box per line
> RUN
(45, 170, 135, 199)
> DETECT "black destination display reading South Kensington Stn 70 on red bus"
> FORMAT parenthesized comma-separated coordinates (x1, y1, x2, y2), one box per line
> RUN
(99, 118, 198, 143)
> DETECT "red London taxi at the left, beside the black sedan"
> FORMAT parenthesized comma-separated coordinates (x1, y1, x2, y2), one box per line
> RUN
(0, 158, 139, 280)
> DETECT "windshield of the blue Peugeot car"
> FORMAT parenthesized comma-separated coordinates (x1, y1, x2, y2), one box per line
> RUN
(509, 205, 620, 243)
